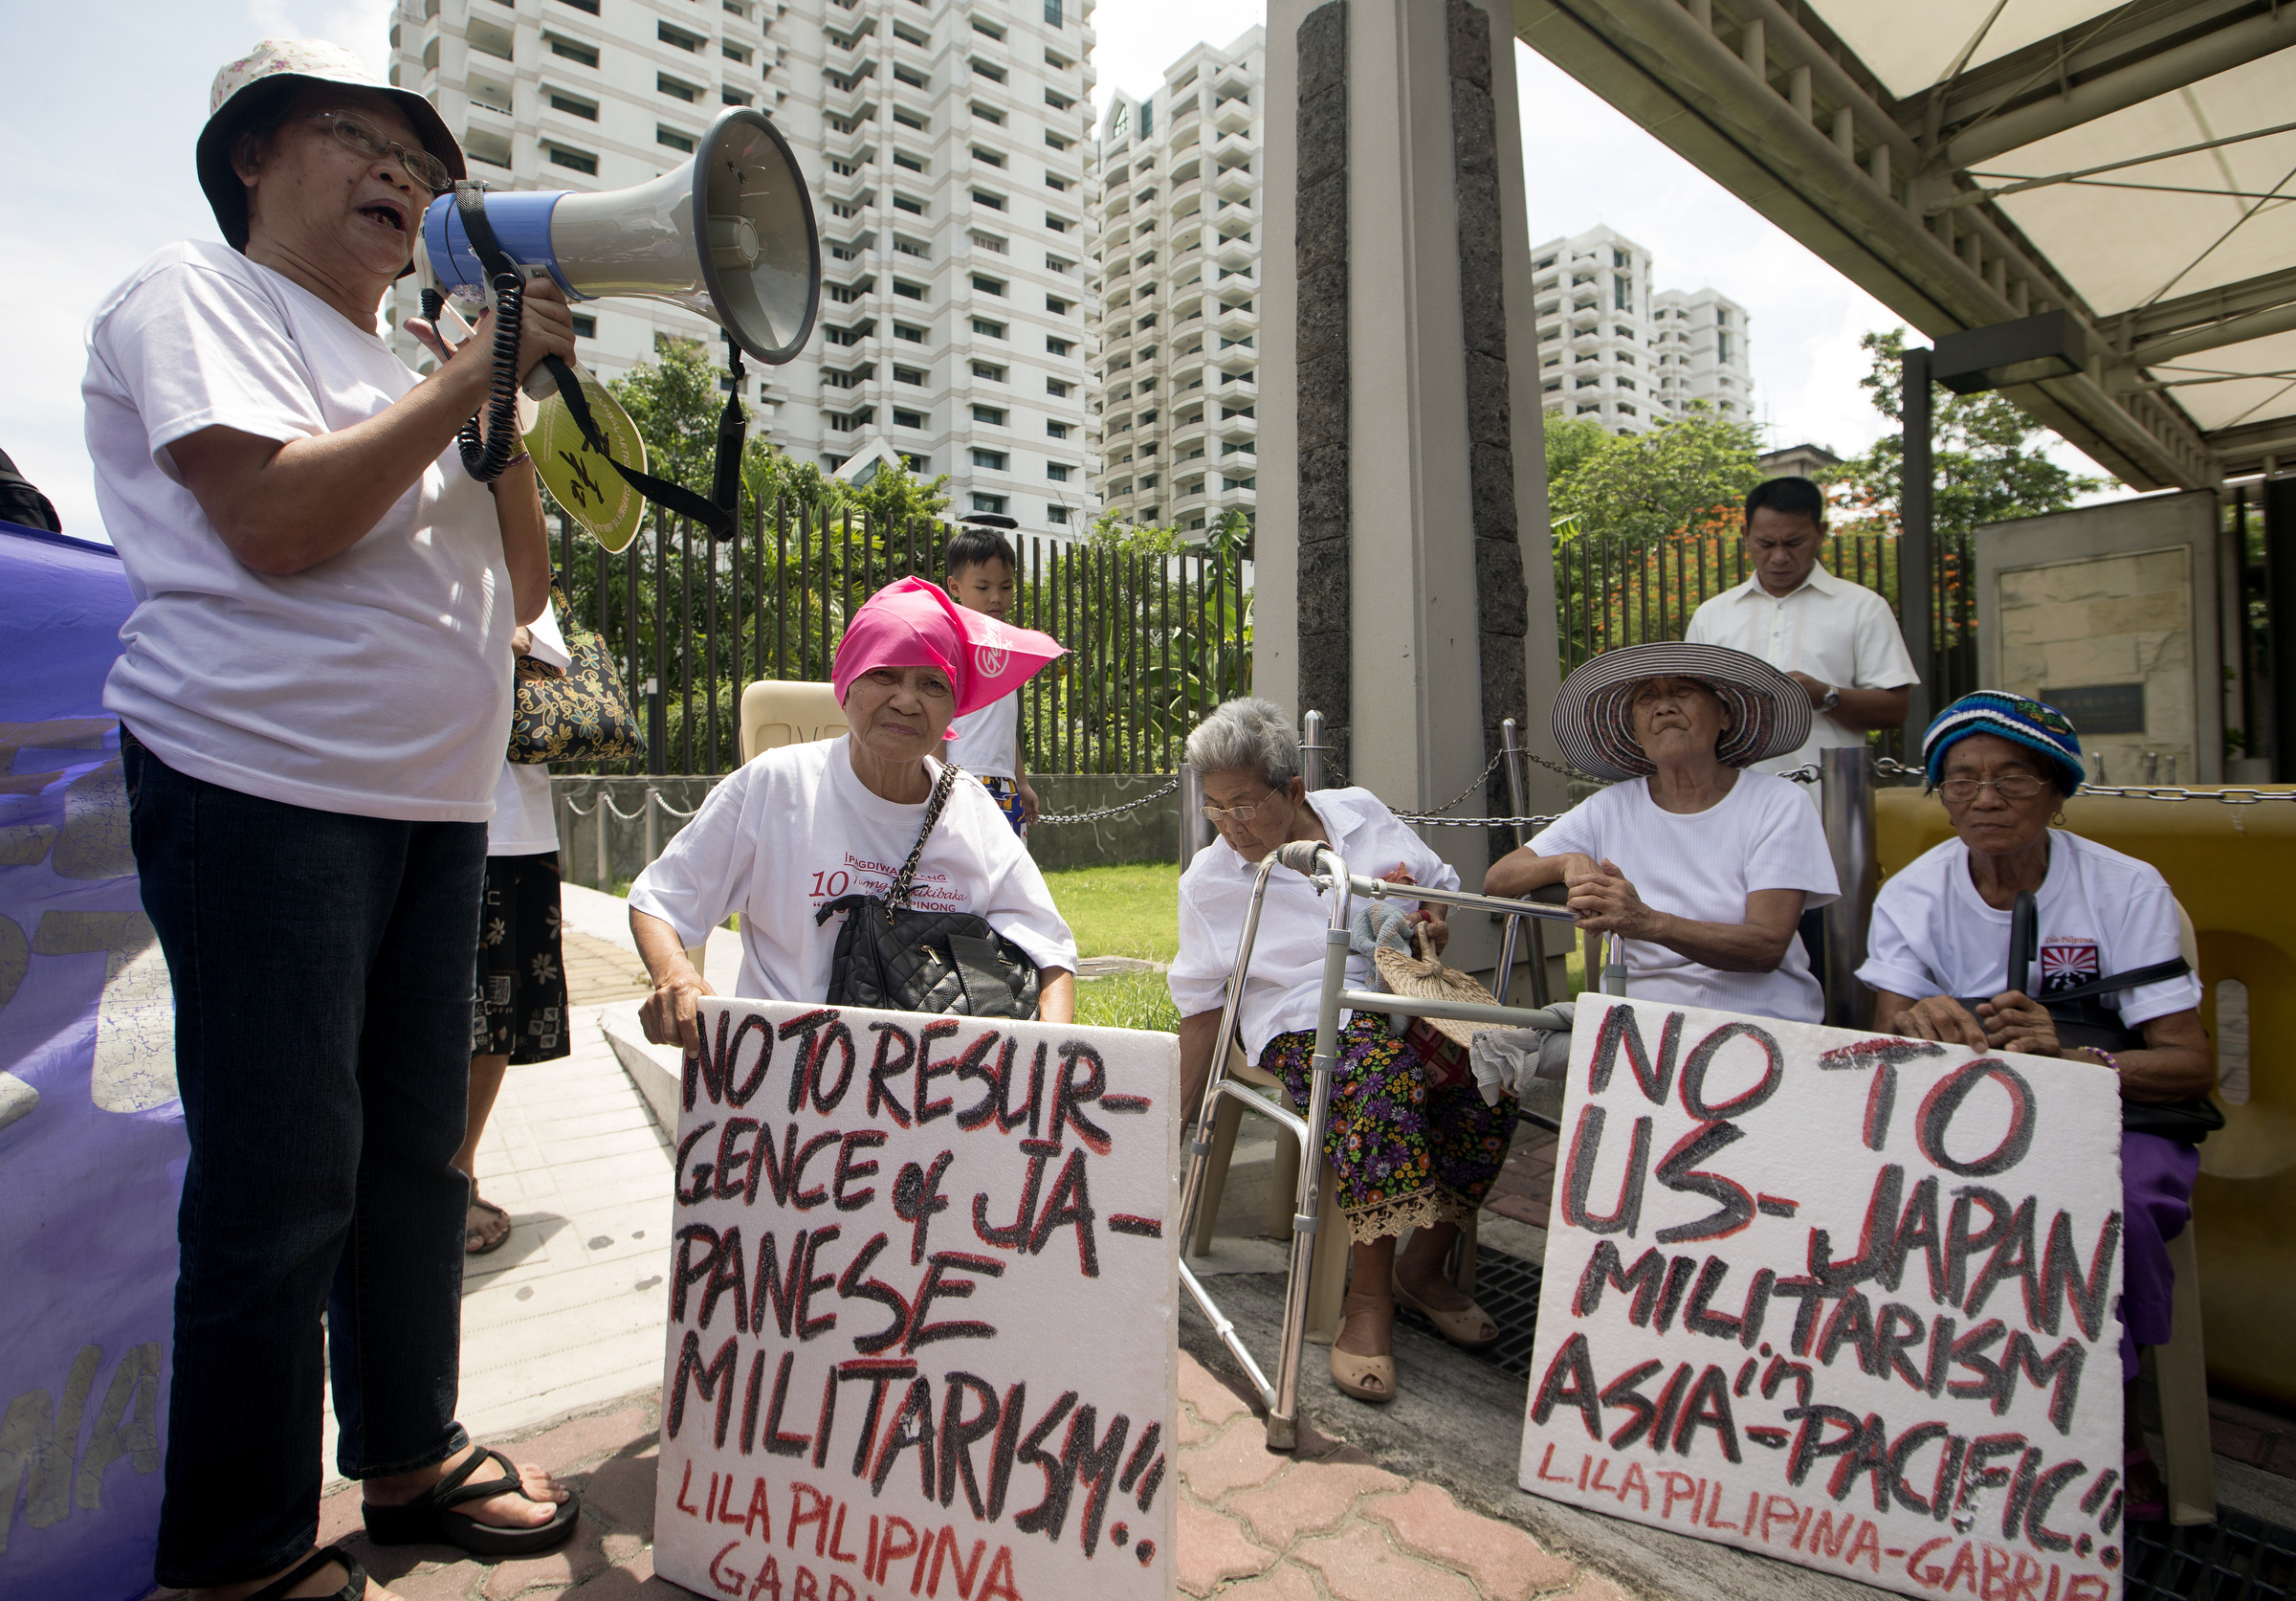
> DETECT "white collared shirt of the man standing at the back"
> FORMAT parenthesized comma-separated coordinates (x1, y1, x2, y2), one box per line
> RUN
(1683, 567, 1919, 781)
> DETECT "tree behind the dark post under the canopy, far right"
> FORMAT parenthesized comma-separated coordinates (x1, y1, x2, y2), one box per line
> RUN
(1830, 328, 2110, 538)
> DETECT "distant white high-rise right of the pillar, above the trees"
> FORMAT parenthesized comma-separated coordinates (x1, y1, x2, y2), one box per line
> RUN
(1532, 228, 1755, 434)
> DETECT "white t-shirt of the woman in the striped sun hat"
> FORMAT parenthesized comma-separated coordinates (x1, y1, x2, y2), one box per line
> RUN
(1532, 771, 1842, 1022)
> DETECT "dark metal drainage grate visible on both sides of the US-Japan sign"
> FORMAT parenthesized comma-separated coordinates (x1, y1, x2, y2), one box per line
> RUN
(1396, 1245, 2296, 1601)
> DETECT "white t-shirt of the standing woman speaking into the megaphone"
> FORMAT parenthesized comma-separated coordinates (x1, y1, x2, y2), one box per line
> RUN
(80, 243, 519, 822)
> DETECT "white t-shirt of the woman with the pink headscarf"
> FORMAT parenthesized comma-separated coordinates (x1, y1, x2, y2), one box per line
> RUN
(629, 735, 1077, 1002)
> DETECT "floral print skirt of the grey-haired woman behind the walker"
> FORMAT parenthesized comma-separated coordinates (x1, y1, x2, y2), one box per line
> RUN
(1261, 1011, 1515, 1245)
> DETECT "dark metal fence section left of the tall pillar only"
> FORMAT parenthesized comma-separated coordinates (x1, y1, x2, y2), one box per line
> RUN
(543, 500, 1251, 776)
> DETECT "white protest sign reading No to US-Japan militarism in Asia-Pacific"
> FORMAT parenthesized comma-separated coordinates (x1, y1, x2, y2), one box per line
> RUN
(1520, 994, 2124, 1601)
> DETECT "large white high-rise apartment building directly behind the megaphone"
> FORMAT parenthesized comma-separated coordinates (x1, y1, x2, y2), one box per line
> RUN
(390, 0, 1093, 533)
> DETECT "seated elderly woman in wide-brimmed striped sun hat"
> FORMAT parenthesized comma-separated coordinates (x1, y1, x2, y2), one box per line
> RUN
(1483, 643, 1839, 1022)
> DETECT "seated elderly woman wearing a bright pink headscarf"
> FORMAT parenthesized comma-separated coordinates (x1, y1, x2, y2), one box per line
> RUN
(629, 579, 1077, 1052)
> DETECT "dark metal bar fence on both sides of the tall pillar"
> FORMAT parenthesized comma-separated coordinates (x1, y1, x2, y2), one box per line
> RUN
(558, 500, 1976, 776)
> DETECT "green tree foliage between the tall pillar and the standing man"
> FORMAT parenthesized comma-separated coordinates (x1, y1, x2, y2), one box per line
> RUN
(1548, 402, 1761, 540)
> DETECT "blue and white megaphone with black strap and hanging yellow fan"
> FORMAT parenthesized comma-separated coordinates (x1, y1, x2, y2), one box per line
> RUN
(420, 105, 822, 549)
